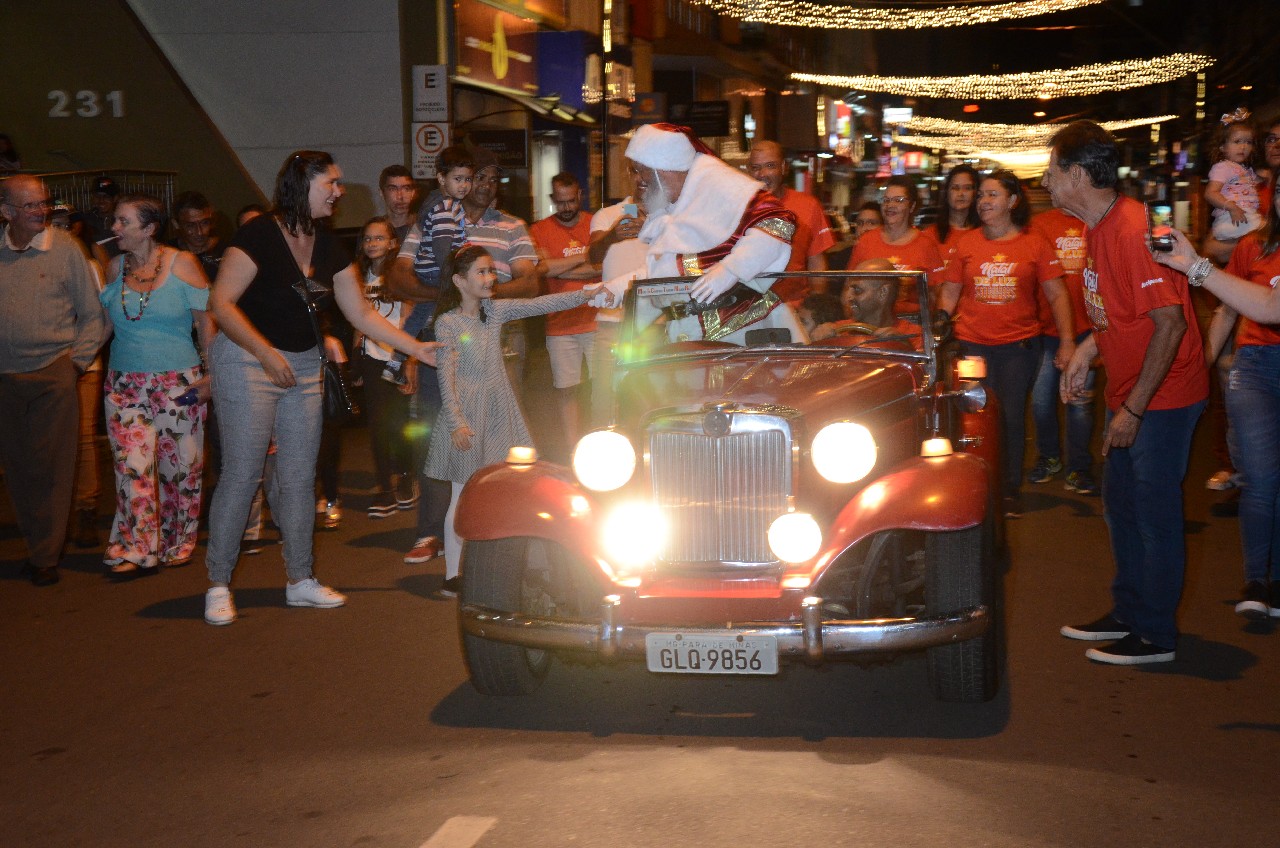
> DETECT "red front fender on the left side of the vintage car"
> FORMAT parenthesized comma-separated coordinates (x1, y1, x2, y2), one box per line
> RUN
(453, 462, 596, 562)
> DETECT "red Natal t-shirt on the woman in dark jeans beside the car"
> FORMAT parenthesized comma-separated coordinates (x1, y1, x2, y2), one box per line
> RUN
(942, 229, 1062, 345)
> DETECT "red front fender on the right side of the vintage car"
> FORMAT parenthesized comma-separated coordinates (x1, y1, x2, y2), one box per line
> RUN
(818, 453, 992, 567)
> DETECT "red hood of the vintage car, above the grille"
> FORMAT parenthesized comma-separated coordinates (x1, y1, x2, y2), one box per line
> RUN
(618, 351, 920, 429)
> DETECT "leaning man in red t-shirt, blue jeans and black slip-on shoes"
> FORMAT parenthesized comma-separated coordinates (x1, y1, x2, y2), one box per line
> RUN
(1042, 120, 1208, 665)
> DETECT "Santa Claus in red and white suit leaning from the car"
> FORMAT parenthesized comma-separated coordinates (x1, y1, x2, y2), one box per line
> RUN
(593, 124, 808, 345)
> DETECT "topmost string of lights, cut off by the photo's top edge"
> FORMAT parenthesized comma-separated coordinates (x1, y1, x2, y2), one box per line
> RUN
(690, 0, 1105, 29)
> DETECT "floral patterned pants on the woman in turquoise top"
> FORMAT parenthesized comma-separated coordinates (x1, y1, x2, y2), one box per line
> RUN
(104, 368, 206, 569)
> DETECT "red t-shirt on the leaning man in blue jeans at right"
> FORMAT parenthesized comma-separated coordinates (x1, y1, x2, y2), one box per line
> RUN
(1084, 196, 1208, 410)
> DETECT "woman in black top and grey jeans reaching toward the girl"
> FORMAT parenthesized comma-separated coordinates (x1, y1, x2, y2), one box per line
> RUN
(205, 150, 435, 624)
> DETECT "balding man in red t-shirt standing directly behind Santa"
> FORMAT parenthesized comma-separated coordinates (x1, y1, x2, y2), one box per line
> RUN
(746, 141, 836, 309)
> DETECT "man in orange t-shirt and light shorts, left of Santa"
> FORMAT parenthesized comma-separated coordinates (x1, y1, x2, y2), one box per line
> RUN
(529, 172, 600, 444)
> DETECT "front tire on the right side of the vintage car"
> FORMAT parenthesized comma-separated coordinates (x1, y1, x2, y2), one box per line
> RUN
(924, 523, 1001, 703)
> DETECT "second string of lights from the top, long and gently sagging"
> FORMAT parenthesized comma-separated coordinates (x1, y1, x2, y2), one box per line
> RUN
(791, 53, 1213, 100)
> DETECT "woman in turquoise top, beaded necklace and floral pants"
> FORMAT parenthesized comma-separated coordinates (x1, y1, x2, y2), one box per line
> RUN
(101, 195, 214, 576)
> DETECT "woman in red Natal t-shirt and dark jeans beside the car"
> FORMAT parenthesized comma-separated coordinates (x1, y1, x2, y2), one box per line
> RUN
(938, 170, 1075, 518)
